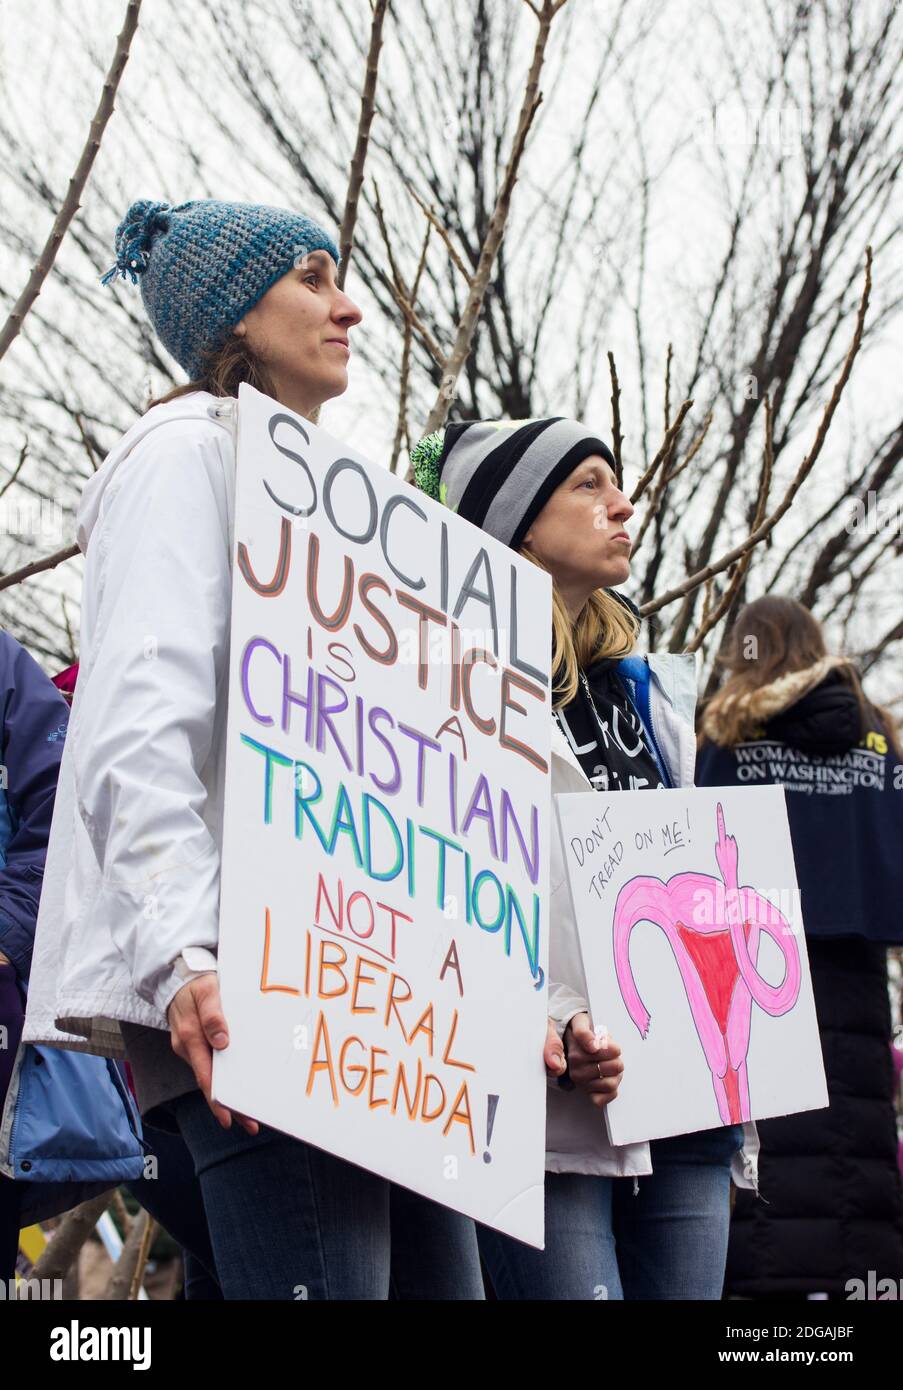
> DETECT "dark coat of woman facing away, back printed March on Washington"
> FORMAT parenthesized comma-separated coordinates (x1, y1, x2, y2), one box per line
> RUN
(696, 673, 903, 1298)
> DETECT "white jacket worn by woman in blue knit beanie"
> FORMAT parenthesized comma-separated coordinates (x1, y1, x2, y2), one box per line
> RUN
(25, 392, 235, 1056)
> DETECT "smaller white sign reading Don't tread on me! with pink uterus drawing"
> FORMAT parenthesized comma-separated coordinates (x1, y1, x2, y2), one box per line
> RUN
(554, 787, 828, 1144)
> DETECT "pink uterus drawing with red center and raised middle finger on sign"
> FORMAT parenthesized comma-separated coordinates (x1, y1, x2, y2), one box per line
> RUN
(614, 803, 800, 1125)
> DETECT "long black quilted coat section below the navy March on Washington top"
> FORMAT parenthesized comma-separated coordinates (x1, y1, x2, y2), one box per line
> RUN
(725, 937, 903, 1298)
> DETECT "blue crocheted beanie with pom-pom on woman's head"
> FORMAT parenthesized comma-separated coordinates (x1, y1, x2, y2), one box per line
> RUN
(101, 199, 339, 379)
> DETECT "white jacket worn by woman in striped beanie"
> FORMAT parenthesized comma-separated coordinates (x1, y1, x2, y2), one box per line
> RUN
(546, 653, 759, 1188)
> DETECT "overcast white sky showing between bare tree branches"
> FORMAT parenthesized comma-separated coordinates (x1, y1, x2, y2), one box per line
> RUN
(0, 0, 903, 684)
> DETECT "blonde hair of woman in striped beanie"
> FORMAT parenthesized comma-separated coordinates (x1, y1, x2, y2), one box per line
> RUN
(520, 546, 640, 709)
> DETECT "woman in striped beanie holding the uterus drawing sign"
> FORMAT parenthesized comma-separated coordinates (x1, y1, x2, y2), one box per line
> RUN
(411, 418, 757, 1300)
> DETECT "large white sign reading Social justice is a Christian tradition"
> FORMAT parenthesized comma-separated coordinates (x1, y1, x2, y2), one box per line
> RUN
(214, 386, 552, 1245)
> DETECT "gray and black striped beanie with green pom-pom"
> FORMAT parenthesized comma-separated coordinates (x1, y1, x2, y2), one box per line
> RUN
(411, 416, 614, 550)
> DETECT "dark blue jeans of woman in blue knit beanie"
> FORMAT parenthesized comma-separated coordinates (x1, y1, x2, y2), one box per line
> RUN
(171, 1091, 483, 1301)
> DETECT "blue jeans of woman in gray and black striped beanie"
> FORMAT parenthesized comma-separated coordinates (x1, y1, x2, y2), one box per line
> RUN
(478, 1125, 743, 1301)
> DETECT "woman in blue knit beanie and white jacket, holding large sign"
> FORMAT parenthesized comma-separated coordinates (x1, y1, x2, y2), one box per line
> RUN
(25, 199, 482, 1300)
